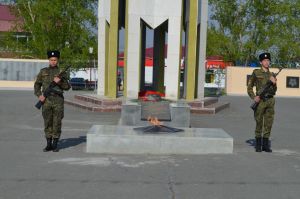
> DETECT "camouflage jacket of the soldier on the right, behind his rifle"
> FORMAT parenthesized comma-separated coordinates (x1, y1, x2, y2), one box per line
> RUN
(247, 68, 277, 99)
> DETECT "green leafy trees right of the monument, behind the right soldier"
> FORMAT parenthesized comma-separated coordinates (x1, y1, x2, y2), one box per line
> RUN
(208, 0, 300, 65)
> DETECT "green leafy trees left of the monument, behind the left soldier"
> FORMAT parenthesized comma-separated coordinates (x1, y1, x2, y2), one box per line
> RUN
(5, 0, 97, 67)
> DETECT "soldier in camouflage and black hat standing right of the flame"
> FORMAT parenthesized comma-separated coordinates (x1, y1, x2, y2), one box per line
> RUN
(247, 53, 277, 152)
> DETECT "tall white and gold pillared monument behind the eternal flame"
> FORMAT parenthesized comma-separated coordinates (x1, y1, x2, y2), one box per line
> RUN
(98, 0, 208, 100)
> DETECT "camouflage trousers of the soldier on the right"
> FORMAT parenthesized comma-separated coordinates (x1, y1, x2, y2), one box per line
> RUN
(254, 98, 275, 138)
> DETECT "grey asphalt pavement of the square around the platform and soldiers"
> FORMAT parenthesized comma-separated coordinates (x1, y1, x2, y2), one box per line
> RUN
(0, 90, 300, 199)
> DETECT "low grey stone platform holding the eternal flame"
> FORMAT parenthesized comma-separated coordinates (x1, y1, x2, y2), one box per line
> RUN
(86, 125, 233, 155)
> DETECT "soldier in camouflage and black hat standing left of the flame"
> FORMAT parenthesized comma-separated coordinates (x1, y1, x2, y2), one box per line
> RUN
(34, 51, 70, 152)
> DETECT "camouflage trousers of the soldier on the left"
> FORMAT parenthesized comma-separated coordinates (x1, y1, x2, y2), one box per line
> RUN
(42, 96, 64, 138)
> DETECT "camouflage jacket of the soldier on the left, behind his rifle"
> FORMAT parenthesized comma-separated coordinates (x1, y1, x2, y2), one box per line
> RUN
(34, 66, 71, 97)
